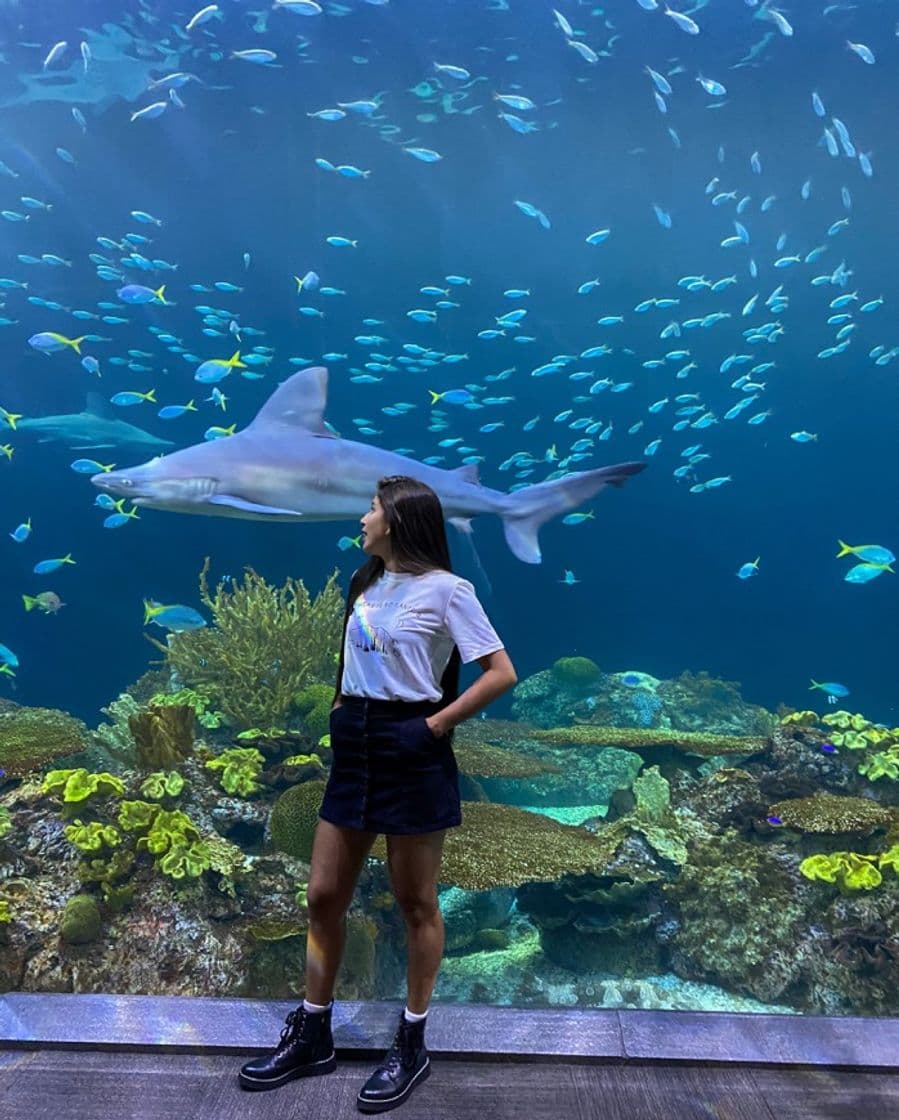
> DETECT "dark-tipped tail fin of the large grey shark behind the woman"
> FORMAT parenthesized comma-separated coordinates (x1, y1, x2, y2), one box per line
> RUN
(497, 463, 647, 563)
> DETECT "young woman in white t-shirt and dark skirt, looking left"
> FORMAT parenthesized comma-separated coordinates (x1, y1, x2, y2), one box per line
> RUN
(240, 475, 517, 1112)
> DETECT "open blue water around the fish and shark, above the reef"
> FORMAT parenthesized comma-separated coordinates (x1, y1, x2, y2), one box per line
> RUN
(0, 0, 899, 725)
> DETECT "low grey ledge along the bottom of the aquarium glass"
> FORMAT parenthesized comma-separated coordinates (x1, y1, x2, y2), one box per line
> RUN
(0, 992, 899, 1071)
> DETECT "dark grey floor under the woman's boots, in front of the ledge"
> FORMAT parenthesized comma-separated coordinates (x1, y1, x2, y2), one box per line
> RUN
(0, 1048, 899, 1120)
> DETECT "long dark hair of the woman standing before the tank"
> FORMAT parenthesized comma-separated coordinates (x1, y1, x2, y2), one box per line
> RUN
(331, 475, 461, 716)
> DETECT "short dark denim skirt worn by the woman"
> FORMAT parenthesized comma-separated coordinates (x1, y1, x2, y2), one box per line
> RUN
(318, 696, 462, 836)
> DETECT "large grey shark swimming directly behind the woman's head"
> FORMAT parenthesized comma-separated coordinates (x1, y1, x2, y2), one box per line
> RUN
(91, 366, 646, 563)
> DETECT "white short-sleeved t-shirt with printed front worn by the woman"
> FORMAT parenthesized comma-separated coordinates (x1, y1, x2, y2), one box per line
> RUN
(340, 568, 504, 700)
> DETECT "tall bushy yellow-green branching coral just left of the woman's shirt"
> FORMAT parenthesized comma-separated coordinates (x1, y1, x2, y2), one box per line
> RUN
(150, 558, 344, 728)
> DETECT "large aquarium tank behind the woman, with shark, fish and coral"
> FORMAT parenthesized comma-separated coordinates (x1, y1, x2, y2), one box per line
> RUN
(0, 0, 899, 1016)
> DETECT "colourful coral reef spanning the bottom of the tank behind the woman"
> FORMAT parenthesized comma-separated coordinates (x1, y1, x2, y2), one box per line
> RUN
(0, 627, 899, 1015)
